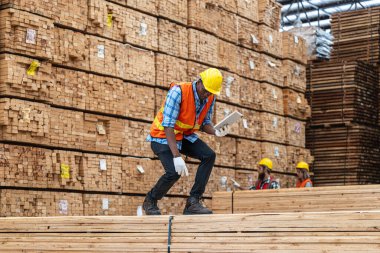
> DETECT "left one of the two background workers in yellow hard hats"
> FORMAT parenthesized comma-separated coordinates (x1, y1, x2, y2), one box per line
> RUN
(234, 158, 280, 190)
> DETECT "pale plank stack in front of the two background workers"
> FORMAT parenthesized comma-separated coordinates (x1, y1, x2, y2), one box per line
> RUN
(212, 185, 380, 214)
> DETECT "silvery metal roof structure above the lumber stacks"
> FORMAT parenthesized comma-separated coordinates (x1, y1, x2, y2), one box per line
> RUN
(277, 0, 380, 31)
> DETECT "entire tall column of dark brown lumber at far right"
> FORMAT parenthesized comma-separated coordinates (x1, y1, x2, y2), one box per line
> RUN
(307, 7, 380, 186)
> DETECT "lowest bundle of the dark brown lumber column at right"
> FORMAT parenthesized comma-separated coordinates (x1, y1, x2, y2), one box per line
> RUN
(307, 124, 380, 186)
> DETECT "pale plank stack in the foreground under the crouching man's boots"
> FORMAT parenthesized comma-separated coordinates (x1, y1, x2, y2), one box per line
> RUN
(0, 211, 380, 253)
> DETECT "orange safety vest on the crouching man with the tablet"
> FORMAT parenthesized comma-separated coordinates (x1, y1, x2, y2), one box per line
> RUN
(150, 83, 214, 141)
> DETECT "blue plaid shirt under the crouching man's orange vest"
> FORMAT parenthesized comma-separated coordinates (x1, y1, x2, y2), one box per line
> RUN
(146, 82, 215, 149)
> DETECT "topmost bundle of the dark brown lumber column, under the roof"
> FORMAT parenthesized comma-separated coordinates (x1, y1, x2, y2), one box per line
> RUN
(331, 7, 380, 63)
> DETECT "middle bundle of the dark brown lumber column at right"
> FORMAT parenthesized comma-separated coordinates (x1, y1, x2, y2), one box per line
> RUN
(307, 61, 379, 126)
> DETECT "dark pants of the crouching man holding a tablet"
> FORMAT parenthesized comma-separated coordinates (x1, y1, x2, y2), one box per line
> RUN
(148, 139, 216, 200)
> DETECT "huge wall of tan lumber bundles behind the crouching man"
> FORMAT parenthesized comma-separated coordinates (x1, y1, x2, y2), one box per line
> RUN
(0, 0, 312, 216)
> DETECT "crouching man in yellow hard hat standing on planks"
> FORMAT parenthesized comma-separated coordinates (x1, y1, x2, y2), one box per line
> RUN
(143, 68, 229, 215)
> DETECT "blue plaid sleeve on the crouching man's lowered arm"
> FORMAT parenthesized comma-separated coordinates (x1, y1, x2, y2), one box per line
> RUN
(162, 86, 182, 127)
